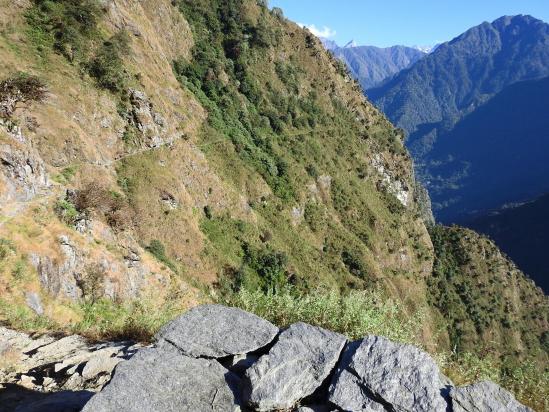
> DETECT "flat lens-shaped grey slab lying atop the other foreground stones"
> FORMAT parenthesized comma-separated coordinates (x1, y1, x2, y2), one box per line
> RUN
(157, 305, 278, 358)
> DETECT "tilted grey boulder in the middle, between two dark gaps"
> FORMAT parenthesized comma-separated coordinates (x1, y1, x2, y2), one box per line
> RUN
(243, 323, 346, 411)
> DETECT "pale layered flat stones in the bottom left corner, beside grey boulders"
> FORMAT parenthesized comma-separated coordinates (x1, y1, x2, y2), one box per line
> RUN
(0, 327, 142, 411)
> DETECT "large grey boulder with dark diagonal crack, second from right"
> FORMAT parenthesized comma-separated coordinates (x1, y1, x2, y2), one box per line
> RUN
(329, 336, 451, 412)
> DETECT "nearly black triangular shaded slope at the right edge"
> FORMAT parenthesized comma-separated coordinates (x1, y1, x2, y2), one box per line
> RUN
(465, 195, 549, 294)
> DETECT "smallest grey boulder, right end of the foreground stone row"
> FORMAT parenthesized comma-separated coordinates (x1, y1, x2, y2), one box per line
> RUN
(450, 381, 532, 412)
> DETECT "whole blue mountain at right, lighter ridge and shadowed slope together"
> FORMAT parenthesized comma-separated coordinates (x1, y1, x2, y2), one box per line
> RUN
(367, 15, 549, 222)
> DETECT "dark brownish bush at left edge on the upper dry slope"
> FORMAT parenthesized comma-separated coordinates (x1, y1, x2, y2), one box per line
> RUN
(0, 73, 47, 119)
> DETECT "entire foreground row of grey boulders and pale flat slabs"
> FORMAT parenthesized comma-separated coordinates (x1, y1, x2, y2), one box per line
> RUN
(0, 305, 530, 412)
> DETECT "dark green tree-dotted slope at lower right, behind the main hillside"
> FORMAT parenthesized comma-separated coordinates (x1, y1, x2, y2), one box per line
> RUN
(428, 226, 549, 363)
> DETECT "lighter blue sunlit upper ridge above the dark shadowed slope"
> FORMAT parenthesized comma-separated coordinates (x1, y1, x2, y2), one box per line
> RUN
(368, 15, 549, 137)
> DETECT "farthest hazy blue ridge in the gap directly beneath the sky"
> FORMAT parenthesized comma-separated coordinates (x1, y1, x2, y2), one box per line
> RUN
(331, 46, 425, 90)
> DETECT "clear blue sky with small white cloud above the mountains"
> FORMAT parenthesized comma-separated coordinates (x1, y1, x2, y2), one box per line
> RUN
(269, 0, 549, 47)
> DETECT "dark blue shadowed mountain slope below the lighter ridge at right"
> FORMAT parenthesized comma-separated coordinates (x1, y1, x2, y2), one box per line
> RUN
(426, 77, 549, 222)
